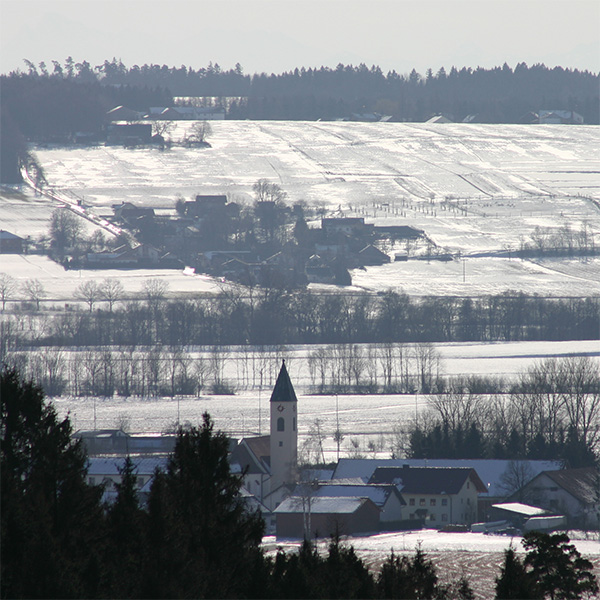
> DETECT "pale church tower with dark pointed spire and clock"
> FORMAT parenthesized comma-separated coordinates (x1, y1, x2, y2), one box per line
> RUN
(269, 360, 298, 492)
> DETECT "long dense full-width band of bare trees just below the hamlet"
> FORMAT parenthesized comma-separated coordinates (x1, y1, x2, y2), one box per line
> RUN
(0, 284, 600, 351)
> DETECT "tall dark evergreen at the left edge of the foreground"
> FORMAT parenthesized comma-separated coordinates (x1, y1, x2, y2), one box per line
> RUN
(0, 369, 103, 598)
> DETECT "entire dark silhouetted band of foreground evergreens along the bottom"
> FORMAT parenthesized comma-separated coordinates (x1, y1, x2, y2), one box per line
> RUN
(0, 370, 598, 600)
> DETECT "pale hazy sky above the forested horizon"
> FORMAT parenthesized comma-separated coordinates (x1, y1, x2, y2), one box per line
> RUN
(0, 0, 600, 73)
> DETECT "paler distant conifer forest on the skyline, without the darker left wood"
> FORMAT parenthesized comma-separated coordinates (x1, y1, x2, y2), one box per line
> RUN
(11, 58, 599, 124)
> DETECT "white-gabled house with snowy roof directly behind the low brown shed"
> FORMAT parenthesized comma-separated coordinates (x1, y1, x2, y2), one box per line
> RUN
(313, 481, 406, 524)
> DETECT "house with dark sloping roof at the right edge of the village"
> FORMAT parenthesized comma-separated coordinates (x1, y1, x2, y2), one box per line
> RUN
(509, 467, 600, 529)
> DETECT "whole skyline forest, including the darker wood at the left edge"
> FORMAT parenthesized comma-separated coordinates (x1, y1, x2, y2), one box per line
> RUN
(0, 57, 600, 183)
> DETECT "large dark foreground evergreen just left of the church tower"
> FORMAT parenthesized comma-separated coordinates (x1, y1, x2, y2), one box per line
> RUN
(145, 413, 264, 598)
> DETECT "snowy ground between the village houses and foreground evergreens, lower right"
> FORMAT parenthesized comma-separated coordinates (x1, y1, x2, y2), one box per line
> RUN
(263, 529, 600, 600)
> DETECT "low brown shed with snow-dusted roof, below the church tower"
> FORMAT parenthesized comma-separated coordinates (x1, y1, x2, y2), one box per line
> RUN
(274, 496, 380, 538)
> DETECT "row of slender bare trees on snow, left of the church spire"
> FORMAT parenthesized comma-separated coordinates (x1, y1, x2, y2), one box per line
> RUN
(2, 346, 292, 397)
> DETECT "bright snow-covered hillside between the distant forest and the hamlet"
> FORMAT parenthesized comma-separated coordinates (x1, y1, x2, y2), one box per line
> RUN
(0, 121, 600, 296)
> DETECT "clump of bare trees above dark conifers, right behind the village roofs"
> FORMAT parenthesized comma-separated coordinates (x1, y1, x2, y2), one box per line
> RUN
(410, 356, 600, 466)
